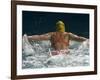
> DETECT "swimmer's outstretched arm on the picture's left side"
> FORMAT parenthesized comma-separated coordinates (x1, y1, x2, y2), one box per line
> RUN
(28, 33, 51, 40)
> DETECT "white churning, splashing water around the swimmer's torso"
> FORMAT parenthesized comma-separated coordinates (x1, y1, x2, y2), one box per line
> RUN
(22, 34, 90, 69)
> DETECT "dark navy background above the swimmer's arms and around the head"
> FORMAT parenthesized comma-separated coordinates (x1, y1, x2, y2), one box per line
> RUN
(22, 11, 89, 38)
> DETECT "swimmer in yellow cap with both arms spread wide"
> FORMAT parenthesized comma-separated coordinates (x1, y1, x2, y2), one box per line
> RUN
(28, 21, 87, 55)
